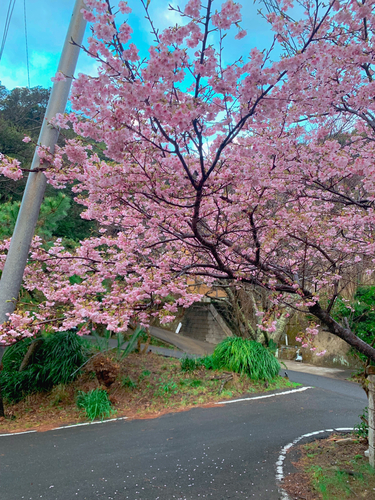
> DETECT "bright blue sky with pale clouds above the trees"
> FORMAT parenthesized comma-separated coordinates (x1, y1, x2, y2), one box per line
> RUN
(0, 0, 272, 89)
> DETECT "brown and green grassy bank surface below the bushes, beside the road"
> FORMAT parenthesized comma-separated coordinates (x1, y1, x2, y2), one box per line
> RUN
(0, 353, 297, 433)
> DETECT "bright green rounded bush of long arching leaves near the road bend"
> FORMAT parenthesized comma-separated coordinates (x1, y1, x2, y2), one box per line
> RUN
(212, 337, 280, 380)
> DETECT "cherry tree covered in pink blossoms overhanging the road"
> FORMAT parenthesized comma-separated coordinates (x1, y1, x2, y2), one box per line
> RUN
(1, 0, 375, 360)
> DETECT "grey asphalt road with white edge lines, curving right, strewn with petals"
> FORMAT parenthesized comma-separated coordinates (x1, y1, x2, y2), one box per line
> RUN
(0, 372, 367, 500)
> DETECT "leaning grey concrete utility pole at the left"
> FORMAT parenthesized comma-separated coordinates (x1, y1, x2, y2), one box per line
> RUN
(0, 0, 86, 352)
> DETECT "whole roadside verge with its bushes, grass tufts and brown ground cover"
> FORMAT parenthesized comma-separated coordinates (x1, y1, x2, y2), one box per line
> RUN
(0, 331, 297, 432)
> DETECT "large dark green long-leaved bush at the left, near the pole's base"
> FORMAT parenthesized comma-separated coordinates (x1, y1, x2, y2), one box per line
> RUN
(0, 331, 88, 402)
